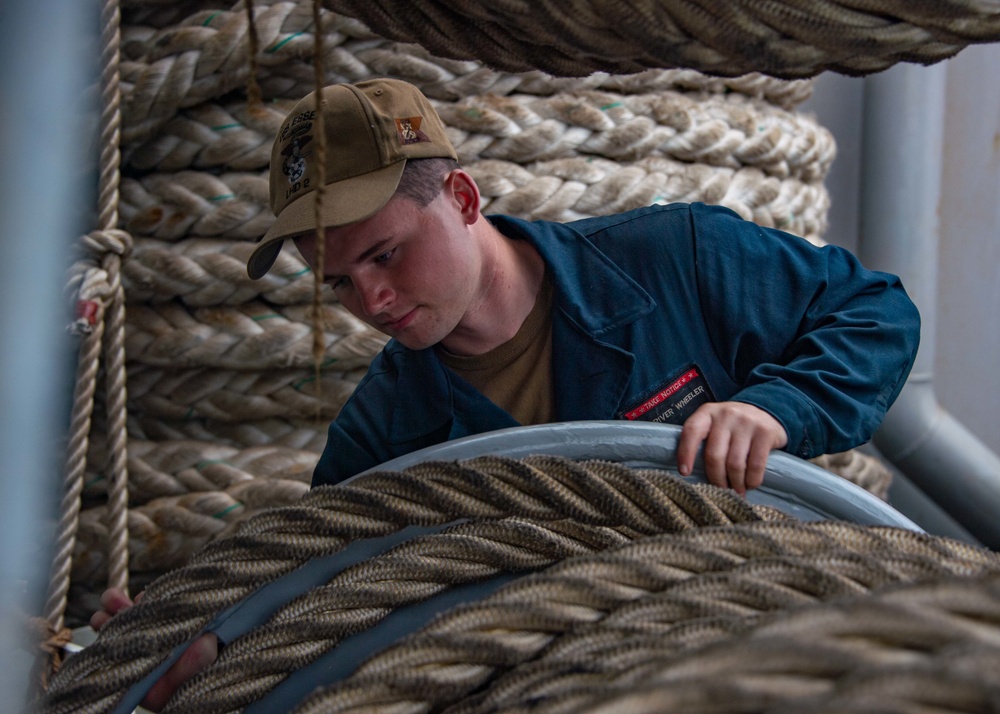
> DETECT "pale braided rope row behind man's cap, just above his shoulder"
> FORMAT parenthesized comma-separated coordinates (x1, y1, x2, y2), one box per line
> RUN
(122, 161, 829, 243)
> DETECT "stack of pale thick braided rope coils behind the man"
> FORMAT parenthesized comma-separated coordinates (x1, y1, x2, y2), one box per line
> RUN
(60, 0, 887, 616)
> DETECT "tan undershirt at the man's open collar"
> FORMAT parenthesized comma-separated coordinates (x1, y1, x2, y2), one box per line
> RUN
(434, 275, 555, 425)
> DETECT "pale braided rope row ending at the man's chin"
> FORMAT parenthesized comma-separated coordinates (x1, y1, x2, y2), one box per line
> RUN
(125, 303, 388, 372)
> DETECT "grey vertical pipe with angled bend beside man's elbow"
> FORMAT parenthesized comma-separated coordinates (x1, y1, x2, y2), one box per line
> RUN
(858, 64, 1000, 549)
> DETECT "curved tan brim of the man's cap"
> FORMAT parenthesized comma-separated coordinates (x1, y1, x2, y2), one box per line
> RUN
(247, 160, 406, 280)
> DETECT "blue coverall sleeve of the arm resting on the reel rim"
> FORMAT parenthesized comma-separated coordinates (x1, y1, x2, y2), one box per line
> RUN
(691, 205, 920, 458)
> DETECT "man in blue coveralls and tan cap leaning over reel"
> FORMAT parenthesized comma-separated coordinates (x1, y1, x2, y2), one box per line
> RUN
(92, 79, 919, 709)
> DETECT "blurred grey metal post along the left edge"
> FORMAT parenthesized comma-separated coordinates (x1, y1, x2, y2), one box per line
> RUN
(0, 0, 100, 700)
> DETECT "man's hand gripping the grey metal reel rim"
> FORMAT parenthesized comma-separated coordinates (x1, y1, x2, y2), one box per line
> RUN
(677, 402, 788, 495)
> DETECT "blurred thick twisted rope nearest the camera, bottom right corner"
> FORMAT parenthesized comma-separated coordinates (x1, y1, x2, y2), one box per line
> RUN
(444, 569, 1000, 714)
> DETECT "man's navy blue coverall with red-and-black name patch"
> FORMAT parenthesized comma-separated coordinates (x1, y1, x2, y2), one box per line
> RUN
(313, 204, 920, 486)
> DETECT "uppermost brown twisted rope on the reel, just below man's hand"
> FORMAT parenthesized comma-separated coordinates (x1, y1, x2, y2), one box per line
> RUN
(43, 456, 780, 712)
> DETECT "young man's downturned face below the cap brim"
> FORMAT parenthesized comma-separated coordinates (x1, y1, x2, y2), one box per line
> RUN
(295, 192, 482, 349)
